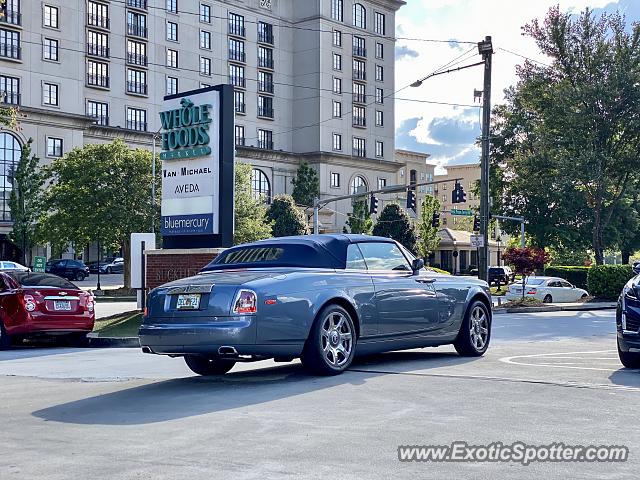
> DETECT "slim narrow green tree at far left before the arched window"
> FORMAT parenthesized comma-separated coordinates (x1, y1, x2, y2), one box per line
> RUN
(9, 139, 44, 265)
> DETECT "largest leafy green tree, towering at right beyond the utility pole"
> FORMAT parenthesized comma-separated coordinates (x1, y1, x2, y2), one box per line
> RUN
(492, 7, 640, 264)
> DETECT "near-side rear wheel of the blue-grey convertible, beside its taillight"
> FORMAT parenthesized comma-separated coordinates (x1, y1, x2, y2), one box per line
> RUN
(300, 305, 357, 375)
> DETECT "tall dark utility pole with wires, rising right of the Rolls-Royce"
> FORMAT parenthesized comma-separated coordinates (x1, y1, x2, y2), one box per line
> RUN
(478, 36, 493, 281)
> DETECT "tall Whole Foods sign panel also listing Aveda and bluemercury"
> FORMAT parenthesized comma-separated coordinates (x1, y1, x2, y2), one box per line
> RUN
(160, 85, 234, 248)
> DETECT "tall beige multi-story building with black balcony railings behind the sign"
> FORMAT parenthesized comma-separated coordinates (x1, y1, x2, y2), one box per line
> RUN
(0, 0, 404, 255)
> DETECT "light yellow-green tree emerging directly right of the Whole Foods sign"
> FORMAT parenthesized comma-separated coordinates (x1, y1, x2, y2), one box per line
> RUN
(233, 163, 271, 245)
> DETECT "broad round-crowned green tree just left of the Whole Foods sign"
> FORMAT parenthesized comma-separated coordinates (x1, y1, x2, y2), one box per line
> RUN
(39, 140, 161, 286)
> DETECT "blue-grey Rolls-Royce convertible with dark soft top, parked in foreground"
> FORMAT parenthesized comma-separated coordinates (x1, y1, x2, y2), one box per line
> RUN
(140, 235, 491, 375)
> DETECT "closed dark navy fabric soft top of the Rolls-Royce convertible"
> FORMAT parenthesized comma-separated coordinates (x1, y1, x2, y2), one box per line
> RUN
(202, 234, 393, 272)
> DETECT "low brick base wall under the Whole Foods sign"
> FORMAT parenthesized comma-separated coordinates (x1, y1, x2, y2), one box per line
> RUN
(145, 248, 223, 289)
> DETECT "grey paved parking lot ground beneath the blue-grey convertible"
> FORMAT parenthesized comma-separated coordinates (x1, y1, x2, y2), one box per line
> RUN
(0, 311, 640, 479)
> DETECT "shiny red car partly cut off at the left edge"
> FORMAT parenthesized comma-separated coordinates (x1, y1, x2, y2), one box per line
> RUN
(0, 272, 95, 348)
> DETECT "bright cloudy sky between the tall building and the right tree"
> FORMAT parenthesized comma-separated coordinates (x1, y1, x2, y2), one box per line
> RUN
(395, 0, 640, 173)
